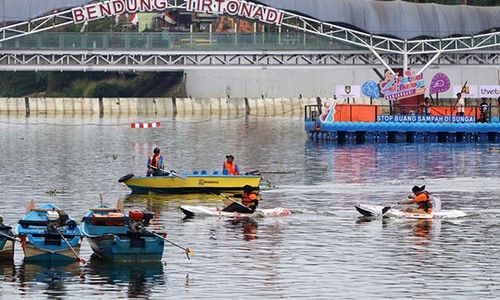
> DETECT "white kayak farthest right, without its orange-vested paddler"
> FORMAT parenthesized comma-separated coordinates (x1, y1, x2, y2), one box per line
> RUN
(354, 204, 467, 219)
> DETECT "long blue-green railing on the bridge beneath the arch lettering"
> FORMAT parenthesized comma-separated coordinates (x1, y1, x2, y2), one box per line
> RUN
(0, 32, 362, 51)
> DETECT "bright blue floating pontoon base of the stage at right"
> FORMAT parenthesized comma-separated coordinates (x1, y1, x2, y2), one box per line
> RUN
(305, 121, 500, 143)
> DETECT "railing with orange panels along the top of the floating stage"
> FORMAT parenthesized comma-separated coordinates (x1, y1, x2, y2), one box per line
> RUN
(304, 104, 500, 123)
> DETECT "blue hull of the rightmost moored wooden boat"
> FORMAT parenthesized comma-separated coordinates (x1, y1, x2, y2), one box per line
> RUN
(88, 234, 165, 262)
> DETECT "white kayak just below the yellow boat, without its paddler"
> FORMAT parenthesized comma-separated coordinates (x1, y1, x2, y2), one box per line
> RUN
(179, 205, 292, 218)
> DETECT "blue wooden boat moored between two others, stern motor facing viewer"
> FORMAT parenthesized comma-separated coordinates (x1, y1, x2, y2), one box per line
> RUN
(16, 200, 83, 262)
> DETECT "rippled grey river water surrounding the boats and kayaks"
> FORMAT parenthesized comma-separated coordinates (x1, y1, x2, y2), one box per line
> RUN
(0, 116, 500, 299)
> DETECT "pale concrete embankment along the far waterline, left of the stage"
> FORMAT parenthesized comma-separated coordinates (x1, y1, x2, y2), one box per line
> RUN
(0, 97, 317, 116)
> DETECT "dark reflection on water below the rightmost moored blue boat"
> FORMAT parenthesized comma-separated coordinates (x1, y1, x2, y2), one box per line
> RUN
(86, 255, 166, 298)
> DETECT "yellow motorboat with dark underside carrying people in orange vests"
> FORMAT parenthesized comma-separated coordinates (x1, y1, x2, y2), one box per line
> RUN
(118, 174, 261, 194)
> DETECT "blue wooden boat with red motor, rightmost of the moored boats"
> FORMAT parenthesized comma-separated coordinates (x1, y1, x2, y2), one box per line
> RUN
(82, 200, 165, 262)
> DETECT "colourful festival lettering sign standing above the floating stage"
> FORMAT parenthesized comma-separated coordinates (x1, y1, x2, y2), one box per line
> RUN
(379, 70, 425, 100)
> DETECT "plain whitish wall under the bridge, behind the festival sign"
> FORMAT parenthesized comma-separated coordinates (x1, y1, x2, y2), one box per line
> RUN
(185, 66, 500, 98)
